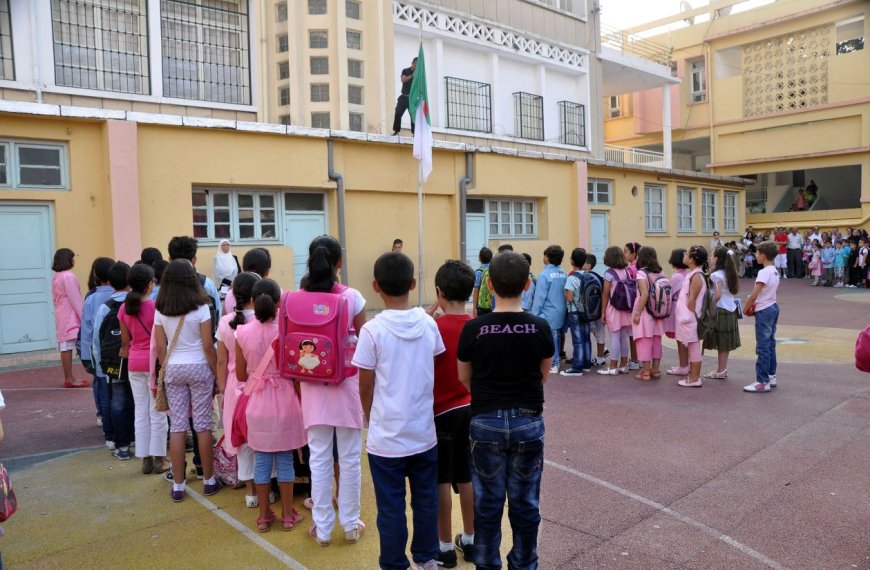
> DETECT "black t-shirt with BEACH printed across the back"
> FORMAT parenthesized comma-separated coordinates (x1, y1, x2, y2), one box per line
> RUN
(457, 312, 554, 415)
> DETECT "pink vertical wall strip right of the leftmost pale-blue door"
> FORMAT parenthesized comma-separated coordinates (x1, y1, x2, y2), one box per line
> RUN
(106, 120, 142, 264)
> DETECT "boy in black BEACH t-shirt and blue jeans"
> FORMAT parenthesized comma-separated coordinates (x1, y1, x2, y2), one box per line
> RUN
(457, 252, 555, 569)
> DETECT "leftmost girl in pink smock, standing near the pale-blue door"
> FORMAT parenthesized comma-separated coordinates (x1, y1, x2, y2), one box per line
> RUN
(51, 247, 88, 388)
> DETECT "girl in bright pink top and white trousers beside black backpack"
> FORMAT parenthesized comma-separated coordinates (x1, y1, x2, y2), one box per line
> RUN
(118, 263, 169, 475)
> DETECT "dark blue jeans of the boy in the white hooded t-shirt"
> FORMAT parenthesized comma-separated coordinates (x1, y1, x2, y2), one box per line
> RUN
(369, 447, 440, 570)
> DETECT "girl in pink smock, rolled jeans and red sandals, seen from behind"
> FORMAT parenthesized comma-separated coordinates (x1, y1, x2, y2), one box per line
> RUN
(236, 279, 307, 532)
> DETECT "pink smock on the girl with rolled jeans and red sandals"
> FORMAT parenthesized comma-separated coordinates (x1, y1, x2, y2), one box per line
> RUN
(236, 319, 308, 452)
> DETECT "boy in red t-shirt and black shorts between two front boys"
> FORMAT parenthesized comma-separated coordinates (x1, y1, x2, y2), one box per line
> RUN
(430, 260, 474, 568)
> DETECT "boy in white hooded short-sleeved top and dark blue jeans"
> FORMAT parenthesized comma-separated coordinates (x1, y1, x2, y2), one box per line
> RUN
(353, 252, 444, 570)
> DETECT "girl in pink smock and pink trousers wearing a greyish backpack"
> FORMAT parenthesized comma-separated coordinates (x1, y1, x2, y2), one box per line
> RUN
(631, 246, 672, 381)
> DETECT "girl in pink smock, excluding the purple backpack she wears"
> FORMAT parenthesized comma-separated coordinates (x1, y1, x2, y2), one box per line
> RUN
(598, 246, 631, 376)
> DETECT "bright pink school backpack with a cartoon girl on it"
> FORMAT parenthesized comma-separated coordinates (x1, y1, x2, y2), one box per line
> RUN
(278, 284, 357, 384)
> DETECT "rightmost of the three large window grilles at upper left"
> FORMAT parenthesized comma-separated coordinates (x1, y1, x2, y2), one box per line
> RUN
(160, 0, 251, 105)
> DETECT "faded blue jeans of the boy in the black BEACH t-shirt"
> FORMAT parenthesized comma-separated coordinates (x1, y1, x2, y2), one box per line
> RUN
(469, 409, 544, 570)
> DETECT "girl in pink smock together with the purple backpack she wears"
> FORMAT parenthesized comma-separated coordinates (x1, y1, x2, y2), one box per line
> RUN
(598, 245, 637, 376)
